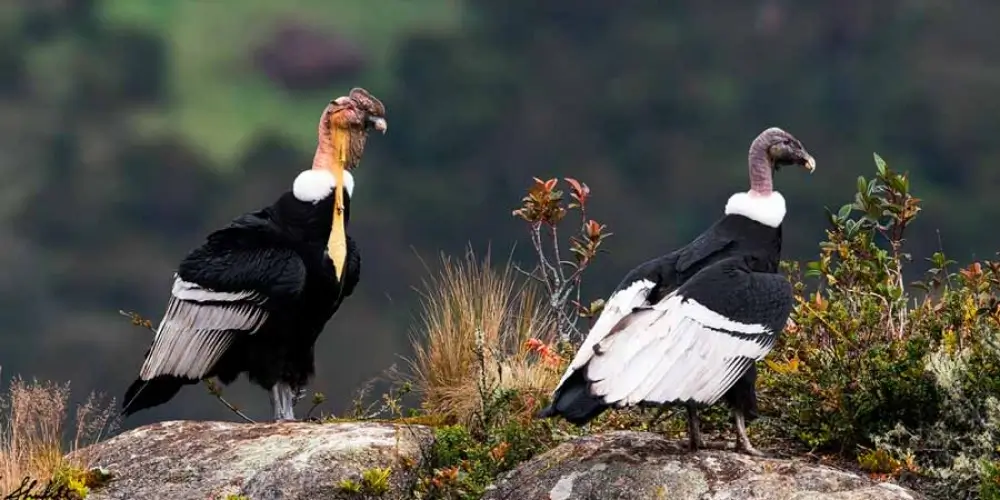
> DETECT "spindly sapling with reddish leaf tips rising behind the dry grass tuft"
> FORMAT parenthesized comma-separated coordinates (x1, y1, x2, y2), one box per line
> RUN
(513, 177, 611, 344)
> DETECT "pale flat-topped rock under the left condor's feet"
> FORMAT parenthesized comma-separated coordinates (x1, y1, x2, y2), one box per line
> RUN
(76, 421, 433, 500)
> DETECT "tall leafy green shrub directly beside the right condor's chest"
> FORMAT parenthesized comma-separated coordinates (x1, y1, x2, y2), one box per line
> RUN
(766, 153, 940, 451)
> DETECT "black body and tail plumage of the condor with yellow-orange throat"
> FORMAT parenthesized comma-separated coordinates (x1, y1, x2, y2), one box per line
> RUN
(123, 185, 361, 415)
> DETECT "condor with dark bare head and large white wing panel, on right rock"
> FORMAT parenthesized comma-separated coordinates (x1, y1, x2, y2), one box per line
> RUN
(538, 128, 816, 455)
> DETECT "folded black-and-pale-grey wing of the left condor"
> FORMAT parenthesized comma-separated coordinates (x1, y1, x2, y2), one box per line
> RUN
(140, 217, 306, 380)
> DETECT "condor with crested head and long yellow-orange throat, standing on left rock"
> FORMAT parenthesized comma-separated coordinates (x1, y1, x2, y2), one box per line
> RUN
(123, 88, 386, 420)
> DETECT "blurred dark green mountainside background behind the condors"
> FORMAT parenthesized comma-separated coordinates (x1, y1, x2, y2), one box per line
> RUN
(0, 0, 1000, 428)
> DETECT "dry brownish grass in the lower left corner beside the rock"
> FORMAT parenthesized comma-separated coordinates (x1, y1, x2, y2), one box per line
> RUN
(0, 370, 118, 494)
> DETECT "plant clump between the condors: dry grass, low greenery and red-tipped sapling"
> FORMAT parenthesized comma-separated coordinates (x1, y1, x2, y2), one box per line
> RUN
(398, 175, 610, 499)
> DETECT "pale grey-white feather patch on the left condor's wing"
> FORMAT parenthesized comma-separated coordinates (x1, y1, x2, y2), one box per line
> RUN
(139, 275, 267, 380)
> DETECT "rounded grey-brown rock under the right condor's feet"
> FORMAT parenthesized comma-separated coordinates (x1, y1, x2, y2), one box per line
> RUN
(485, 431, 921, 500)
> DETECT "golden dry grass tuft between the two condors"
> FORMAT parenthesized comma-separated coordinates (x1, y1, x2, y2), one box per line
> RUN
(411, 250, 561, 425)
